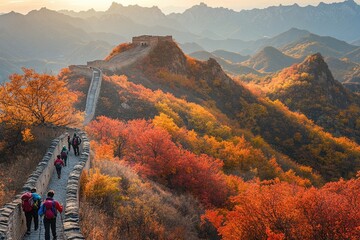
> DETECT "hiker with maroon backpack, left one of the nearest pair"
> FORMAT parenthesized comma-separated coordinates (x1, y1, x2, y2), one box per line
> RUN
(21, 187, 41, 235)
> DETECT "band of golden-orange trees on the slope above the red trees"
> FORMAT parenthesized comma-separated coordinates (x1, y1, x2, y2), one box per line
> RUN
(104, 76, 321, 185)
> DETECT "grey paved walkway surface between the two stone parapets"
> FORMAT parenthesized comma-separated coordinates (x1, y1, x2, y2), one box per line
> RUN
(24, 149, 80, 240)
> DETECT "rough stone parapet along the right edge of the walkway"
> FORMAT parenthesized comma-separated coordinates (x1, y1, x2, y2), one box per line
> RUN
(64, 132, 90, 240)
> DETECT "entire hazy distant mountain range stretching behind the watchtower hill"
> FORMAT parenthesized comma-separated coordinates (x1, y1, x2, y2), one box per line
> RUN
(0, 1, 360, 81)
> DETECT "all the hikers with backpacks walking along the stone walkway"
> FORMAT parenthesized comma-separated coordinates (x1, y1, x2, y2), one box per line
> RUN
(21, 133, 81, 240)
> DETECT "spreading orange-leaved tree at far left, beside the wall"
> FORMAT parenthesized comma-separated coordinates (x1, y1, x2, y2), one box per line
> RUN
(0, 68, 80, 126)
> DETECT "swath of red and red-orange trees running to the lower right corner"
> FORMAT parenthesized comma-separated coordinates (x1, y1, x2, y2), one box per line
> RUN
(85, 117, 360, 240)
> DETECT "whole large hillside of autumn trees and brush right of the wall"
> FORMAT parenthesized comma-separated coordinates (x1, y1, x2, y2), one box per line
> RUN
(61, 37, 360, 239)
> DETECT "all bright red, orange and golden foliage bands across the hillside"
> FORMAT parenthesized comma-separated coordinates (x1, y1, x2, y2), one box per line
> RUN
(86, 77, 360, 239)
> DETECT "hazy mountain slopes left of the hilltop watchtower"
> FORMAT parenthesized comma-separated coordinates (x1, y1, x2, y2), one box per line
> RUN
(0, 9, 113, 81)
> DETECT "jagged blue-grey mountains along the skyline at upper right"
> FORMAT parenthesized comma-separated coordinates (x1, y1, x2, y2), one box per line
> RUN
(169, 0, 360, 41)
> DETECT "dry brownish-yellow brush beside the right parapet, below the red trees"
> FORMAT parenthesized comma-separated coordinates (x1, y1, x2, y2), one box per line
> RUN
(80, 162, 208, 239)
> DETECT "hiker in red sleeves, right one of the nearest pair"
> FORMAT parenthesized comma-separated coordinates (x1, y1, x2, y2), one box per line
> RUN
(39, 190, 63, 240)
